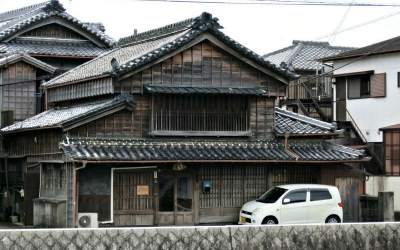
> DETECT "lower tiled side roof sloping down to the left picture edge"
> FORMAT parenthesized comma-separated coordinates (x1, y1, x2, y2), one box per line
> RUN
(1, 93, 136, 132)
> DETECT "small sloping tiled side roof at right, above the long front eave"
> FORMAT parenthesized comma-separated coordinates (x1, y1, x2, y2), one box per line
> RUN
(275, 108, 341, 136)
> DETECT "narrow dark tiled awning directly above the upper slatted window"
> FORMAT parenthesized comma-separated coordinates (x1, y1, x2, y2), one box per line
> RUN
(144, 85, 267, 95)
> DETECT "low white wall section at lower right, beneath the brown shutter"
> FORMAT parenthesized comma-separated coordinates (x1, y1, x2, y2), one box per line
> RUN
(365, 176, 400, 211)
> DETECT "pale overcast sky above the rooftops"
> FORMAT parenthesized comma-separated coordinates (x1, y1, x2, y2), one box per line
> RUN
(0, 0, 400, 54)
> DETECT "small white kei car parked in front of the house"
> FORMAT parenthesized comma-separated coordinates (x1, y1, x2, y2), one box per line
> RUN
(239, 184, 343, 225)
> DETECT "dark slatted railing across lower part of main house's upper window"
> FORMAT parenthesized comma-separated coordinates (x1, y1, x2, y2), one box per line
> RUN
(153, 110, 250, 131)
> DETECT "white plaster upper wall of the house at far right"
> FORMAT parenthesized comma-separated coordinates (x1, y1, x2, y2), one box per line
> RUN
(334, 52, 400, 142)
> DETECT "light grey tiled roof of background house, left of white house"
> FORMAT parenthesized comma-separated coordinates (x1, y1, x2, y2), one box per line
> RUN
(264, 40, 354, 70)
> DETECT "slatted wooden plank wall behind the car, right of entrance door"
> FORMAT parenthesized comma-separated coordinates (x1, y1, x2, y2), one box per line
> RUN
(198, 164, 321, 223)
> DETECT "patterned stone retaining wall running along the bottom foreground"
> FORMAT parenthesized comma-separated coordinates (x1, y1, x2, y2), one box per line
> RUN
(0, 223, 400, 250)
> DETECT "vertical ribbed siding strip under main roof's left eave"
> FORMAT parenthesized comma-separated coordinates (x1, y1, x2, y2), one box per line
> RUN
(47, 77, 114, 102)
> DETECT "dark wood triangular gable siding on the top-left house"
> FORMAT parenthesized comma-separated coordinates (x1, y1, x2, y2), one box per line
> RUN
(20, 23, 87, 40)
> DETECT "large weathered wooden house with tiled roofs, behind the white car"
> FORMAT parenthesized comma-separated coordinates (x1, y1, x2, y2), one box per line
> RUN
(2, 13, 368, 227)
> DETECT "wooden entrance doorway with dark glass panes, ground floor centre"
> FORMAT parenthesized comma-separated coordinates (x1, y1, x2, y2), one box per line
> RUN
(158, 172, 194, 225)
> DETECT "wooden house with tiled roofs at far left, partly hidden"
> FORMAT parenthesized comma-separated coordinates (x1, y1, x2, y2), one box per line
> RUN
(0, 0, 115, 224)
